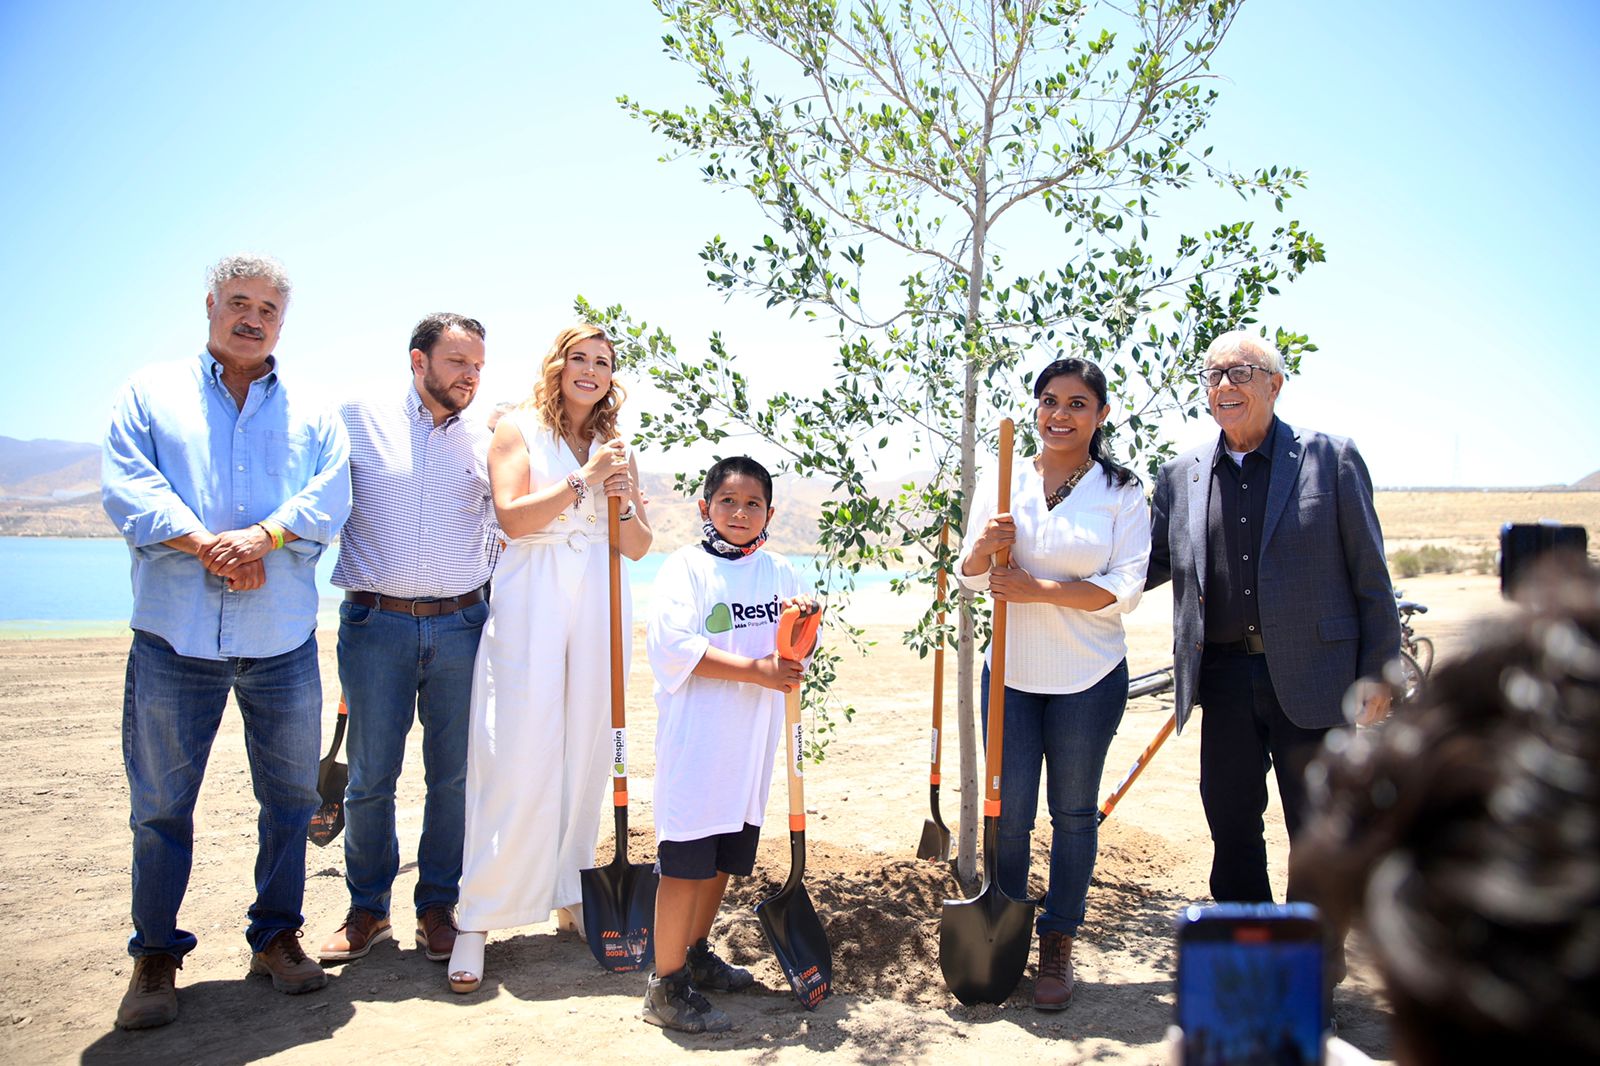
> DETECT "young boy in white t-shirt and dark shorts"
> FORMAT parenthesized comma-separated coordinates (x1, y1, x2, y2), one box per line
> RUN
(643, 456, 805, 1032)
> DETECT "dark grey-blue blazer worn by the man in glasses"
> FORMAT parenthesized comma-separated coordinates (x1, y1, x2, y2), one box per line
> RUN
(1146, 421, 1400, 730)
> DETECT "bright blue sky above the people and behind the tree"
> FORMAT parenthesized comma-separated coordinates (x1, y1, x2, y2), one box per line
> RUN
(0, 0, 1600, 485)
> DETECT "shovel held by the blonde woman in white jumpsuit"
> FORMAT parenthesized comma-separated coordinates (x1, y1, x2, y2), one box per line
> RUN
(578, 496, 659, 973)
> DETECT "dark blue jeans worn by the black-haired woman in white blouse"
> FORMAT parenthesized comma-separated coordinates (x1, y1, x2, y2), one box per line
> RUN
(982, 659, 1128, 936)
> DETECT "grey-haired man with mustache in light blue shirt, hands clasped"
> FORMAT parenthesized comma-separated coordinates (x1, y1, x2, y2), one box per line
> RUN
(101, 256, 350, 1029)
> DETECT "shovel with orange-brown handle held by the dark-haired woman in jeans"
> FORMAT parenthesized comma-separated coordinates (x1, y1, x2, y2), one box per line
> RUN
(939, 418, 1034, 1007)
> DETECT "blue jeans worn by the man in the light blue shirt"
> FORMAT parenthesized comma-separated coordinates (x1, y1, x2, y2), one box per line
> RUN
(122, 631, 322, 959)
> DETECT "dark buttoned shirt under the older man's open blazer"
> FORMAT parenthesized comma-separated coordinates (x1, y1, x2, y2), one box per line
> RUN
(1205, 418, 1282, 643)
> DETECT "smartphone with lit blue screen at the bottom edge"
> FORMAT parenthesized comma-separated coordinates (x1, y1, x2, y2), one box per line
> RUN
(1174, 903, 1328, 1066)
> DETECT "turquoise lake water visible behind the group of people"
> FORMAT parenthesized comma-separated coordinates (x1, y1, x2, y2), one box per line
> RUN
(0, 536, 890, 637)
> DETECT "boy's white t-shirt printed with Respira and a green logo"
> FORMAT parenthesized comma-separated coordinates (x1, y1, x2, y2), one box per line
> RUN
(645, 544, 798, 844)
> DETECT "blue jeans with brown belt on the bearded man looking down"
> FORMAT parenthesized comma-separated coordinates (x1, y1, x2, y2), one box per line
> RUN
(339, 600, 490, 916)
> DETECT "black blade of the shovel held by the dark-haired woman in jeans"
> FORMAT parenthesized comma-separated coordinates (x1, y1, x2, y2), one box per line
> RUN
(939, 818, 1035, 1007)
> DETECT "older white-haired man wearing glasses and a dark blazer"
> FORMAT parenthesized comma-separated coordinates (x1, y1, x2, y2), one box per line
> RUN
(1147, 331, 1400, 976)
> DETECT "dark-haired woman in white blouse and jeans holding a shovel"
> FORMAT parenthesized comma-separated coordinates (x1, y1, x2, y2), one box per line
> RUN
(957, 359, 1150, 1010)
